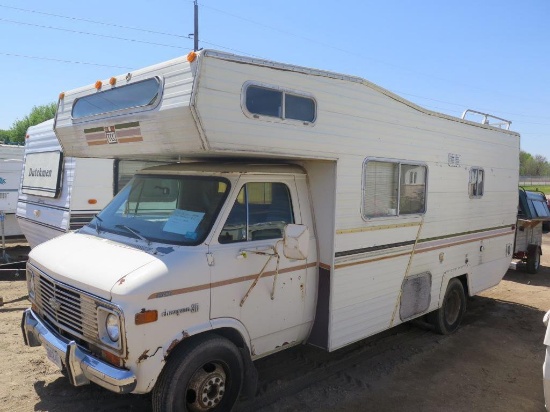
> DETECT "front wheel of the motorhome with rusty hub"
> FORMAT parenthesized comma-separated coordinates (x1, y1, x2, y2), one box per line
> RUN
(152, 336, 244, 412)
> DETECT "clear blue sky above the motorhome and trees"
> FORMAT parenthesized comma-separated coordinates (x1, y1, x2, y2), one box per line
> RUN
(0, 0, 550, 160)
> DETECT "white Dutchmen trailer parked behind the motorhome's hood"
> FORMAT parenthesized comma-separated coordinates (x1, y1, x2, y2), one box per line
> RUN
(16, 119, 163, 248)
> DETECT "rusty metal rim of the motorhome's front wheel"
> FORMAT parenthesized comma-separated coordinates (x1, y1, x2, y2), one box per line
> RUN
(186, 363, 226, 412)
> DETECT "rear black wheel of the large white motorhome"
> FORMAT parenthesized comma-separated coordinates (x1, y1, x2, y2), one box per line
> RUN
(428, 278, 466, 335)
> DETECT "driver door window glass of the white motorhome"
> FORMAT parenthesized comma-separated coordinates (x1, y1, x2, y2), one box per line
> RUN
(218, 182, 294, 243)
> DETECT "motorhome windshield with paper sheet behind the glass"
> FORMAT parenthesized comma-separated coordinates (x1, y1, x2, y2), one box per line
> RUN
(88, 175, 229, 245)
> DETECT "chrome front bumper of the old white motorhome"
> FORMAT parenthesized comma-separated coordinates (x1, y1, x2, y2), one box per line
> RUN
(21, 309, 137, 393)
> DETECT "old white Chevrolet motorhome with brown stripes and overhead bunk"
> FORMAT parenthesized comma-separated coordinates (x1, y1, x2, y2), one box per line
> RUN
(22, 50, 519, 411)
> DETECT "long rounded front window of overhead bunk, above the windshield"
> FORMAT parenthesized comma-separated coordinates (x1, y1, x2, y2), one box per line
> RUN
(72, 77, 161, 119)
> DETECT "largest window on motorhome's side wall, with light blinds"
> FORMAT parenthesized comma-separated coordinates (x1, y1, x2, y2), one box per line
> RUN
(363, 160, 427, 218)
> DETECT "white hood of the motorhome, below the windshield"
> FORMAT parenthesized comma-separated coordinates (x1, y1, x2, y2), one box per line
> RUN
(29, 233, 157, 300)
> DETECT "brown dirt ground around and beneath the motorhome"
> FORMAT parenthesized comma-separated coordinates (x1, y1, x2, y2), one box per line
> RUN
(0, 238, 550, 412)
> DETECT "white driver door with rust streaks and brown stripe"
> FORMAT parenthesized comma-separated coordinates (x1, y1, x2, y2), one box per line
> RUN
(210, 176, 311, 355)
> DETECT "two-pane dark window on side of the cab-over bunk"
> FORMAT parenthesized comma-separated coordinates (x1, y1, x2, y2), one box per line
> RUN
(245, 85, 315, 123)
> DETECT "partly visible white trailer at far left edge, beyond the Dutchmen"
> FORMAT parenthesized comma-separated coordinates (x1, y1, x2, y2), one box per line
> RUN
(0, 144, 24, 240)
